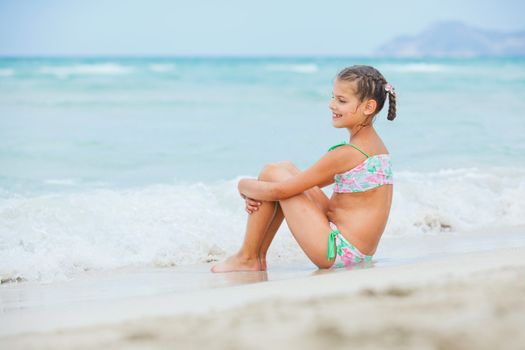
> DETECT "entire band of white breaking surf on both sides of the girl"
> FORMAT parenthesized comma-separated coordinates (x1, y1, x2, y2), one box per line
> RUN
(0, 168, 525, 282)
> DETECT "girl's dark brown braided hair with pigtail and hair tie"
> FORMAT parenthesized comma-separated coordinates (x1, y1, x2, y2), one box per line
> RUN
(337, 65, 396, 126)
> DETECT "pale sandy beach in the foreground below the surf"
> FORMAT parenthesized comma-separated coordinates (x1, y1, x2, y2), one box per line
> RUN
(0, 242, 525, 349)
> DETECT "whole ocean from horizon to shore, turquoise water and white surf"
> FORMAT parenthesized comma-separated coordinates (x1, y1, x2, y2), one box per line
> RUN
(0, 57, 525, 282)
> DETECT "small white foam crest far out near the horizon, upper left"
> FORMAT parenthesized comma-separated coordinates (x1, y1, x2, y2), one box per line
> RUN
(38, 63, 133, 78)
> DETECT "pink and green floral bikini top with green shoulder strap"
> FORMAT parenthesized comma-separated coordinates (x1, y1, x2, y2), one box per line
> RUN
(328, 141, 393, 193)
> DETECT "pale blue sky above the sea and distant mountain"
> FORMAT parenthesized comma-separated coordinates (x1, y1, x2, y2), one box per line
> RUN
(0, 0, 525, 56)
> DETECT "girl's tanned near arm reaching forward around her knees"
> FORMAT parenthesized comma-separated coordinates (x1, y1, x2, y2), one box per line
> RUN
(238, 147, 357, 201)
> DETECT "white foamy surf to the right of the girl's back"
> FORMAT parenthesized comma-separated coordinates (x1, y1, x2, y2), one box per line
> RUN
(388, 168, 525, 235)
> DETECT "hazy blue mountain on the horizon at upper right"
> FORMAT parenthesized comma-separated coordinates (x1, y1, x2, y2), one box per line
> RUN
(375, 22, 525, 57)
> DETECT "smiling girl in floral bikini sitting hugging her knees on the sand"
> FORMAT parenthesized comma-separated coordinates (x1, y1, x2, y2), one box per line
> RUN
(211, 66, 396, 272)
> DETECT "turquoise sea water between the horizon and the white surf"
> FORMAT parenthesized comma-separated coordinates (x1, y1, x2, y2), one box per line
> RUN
(0, 58, 525, 193)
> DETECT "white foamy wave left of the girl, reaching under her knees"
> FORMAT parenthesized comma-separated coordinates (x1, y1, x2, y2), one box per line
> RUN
(0, 180, 299, 282)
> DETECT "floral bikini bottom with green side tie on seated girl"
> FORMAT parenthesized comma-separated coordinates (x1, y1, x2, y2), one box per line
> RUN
(328, 222, 372, 268)
